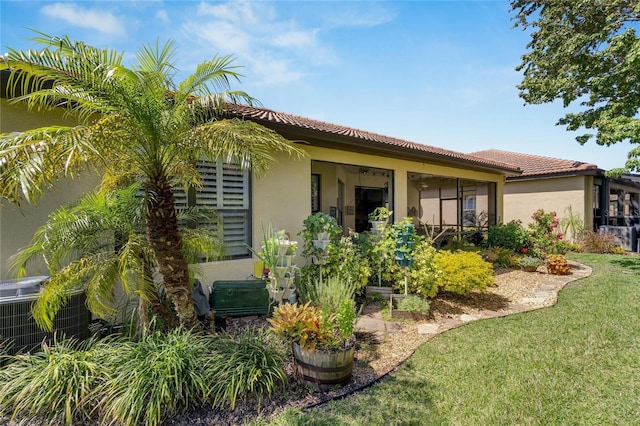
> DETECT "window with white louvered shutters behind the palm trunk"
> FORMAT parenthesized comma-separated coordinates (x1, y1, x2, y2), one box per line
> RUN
(174, 160, 251, 257)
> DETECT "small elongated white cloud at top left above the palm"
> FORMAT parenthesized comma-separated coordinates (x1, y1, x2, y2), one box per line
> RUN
(41, 3, 125, 35)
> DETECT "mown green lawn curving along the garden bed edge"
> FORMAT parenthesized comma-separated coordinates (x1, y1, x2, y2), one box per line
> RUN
(273, 254, 640, 425)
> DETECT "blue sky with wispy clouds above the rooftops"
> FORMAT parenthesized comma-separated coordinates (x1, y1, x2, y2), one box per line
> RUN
(0, 0, 630, 169)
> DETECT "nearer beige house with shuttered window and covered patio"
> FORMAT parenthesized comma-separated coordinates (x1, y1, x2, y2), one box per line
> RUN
(0, 90, 520, 283)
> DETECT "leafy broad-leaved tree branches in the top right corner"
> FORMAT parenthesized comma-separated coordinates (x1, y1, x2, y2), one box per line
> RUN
(511, 0, 640, 171)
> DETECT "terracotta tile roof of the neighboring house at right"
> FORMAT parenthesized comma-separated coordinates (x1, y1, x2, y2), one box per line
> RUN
(470, 149, 601, 179)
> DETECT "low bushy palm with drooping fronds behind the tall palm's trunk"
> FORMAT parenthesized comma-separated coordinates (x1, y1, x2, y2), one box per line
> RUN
(10, 182, 224, 330)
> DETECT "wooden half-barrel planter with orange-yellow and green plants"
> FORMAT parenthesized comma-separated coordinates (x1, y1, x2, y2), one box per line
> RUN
(268, 277, 358, 389)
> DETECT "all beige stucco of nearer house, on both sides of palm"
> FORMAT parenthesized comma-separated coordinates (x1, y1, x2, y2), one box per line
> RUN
(0, 99, 504, 284)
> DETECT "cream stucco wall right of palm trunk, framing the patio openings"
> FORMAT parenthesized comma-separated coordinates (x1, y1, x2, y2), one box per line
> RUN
(195, 146, 504, 284)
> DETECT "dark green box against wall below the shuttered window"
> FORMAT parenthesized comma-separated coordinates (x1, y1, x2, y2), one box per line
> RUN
(209, 280, 269, 317)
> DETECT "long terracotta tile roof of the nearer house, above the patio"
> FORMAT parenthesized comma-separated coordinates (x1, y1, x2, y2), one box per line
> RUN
(226, 105, 520, 175)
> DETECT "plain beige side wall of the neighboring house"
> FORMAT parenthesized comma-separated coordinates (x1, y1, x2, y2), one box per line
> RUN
(502, 176, 593, 241)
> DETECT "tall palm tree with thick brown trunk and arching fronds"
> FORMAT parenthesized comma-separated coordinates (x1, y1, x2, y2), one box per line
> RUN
(0, 33, 304, 327)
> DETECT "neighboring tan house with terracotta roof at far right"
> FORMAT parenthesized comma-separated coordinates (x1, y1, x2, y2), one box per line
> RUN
(471, 149, 640, 251)
